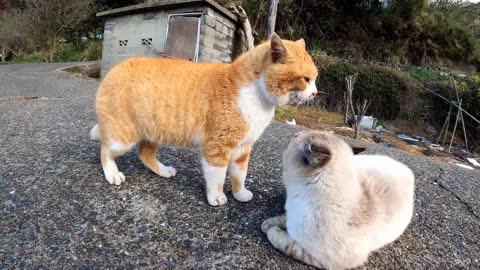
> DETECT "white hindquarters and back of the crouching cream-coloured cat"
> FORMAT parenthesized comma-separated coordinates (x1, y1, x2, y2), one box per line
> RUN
(354, 155, 415, 250)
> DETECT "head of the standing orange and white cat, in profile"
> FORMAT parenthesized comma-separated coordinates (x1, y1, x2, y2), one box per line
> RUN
(263, 34, 318, 105)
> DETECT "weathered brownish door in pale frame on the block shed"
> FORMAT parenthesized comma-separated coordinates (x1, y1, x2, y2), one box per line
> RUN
(165, 15, 200, 61)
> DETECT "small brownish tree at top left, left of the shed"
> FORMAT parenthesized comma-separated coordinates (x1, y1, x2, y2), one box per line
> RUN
(23, 0, 95, 62)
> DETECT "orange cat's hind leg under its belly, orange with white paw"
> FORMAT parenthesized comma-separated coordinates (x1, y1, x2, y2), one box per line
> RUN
(137, 141, 177, 178)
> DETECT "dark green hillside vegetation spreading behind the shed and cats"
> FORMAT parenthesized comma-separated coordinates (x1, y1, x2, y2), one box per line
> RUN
(0, 0, 480, 152)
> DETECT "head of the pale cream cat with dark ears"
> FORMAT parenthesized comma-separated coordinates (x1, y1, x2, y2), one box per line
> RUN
(283, 131, 353, 176)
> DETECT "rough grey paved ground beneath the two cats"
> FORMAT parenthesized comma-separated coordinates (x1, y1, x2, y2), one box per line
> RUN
(0, 64, 480, 269)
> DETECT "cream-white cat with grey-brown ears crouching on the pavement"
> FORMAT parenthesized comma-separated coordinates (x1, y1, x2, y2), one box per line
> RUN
(262, 131, 414, 269)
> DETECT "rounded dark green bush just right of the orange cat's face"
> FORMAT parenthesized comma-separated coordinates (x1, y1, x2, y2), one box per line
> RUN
(318, 63, 419, 120)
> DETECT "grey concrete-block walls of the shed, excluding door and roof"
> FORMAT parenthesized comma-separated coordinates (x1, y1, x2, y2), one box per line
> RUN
(102, 7, 236, 76)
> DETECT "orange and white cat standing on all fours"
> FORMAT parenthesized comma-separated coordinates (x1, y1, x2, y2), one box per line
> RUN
(90, 34, 318, 206)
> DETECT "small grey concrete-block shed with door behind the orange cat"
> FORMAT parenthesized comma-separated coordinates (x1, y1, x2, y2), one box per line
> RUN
(97, 0, 240, 76)
